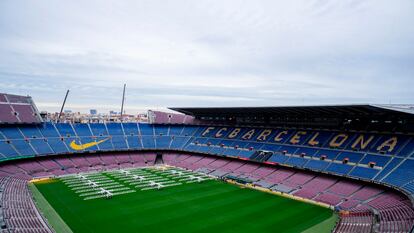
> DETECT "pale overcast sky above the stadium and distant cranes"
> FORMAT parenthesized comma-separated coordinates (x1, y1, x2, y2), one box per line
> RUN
(0, 0, 414, 113)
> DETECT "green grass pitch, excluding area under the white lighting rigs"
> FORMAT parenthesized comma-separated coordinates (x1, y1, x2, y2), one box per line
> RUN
(32, 167, 336, 233)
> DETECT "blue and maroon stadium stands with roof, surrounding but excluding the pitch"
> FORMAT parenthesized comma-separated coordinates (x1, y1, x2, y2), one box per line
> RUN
(0, 94, 414, 232)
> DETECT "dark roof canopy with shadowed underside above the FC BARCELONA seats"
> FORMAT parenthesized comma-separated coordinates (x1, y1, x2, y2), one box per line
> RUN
(170, 104, 414, 133)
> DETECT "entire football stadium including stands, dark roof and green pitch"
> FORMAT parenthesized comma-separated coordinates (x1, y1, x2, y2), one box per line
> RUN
(0, 94, 414, 233)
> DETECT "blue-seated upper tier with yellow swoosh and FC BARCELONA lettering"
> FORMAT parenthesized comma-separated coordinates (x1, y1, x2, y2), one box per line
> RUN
(0, 123, 414, 196)
